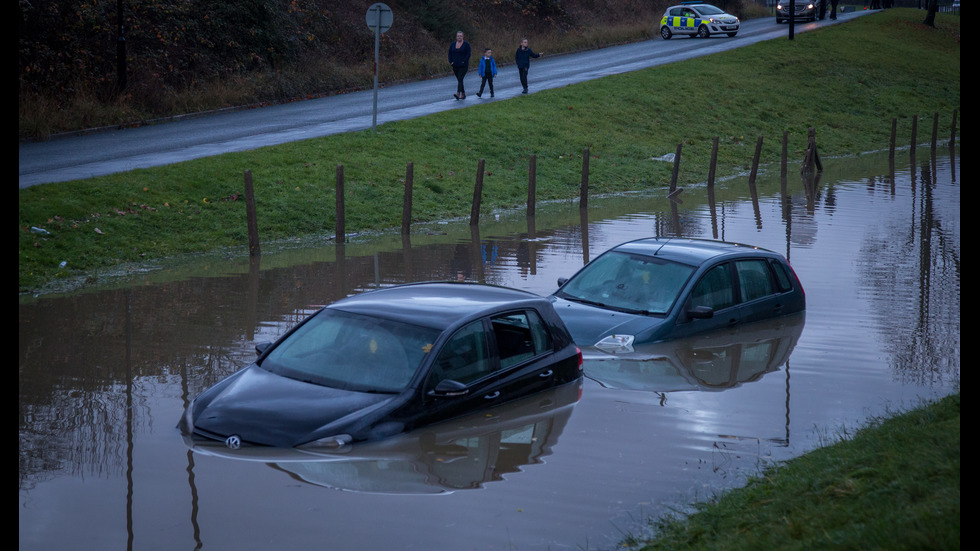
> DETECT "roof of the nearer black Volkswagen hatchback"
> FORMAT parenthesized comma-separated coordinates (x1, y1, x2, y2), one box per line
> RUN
(327, 281, 551, 330)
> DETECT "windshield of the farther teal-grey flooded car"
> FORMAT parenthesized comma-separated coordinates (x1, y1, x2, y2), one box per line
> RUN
(558, 251, 695, 314)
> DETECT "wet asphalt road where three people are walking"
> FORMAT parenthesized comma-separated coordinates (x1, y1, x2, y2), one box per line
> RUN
(19, 11, 870, 188)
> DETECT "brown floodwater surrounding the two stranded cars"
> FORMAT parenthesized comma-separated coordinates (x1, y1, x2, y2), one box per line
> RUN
(18, 147, 961, 551)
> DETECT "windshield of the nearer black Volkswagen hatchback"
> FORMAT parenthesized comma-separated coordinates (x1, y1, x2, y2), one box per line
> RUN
(261, 308, 439, 392)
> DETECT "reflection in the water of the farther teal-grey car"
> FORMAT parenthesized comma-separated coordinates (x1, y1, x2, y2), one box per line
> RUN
(582, 312, 806, 392)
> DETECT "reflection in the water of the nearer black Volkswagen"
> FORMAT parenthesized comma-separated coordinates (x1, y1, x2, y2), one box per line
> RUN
(184, 378, 583, 494)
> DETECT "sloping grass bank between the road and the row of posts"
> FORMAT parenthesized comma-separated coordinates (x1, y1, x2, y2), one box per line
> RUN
(18, 9, 960, 293)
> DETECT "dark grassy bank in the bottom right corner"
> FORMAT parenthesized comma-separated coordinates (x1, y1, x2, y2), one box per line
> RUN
(633, 393, 960, 551)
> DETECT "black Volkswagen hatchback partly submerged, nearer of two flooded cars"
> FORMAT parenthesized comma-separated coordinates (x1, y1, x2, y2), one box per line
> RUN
(178, 282, 582, 448)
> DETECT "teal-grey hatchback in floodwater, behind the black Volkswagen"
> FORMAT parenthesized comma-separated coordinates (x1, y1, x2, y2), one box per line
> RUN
(550, 237, 806, 349)
